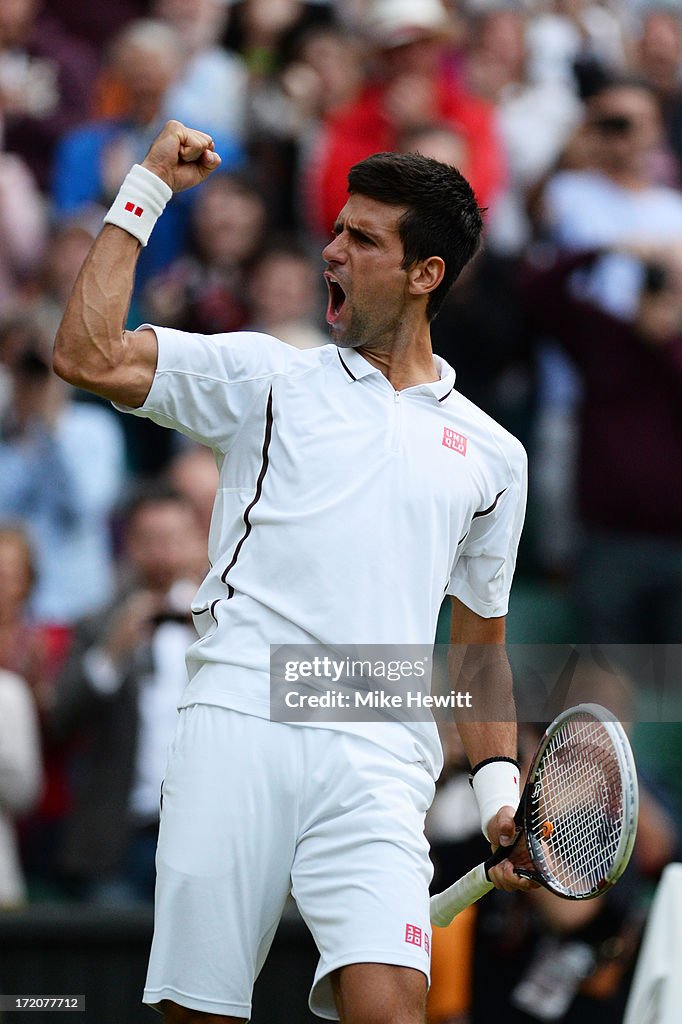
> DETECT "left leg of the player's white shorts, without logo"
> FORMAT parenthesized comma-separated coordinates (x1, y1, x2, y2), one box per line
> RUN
(144, 705, 297, 1020)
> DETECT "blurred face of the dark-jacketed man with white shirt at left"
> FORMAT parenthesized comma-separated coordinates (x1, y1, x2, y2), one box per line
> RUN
(126, 499, 201, 592)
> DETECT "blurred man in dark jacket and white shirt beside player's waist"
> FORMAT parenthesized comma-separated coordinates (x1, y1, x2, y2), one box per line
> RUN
(48, 489, 203, 901)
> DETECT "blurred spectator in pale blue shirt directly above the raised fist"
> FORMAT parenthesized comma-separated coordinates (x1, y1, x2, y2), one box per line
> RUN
(153, 0, 248, 139)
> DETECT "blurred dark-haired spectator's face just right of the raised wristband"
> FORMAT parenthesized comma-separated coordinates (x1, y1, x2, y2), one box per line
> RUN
(193, 177, 265, 268)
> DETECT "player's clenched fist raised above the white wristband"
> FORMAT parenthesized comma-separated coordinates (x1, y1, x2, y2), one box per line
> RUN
(142, 121, 220, 193)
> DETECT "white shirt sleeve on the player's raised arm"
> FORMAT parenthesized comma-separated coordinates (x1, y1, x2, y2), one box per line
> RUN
(116, 324, 297, 453)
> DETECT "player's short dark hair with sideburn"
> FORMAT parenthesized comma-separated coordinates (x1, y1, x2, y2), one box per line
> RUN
(348, 153, 483, 321)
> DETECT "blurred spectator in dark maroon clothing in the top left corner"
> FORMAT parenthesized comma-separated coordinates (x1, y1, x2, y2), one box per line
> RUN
(0, 0, 97, 188)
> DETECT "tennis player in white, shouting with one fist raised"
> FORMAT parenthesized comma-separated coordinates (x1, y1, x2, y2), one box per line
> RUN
(54, 121, 528, 1024)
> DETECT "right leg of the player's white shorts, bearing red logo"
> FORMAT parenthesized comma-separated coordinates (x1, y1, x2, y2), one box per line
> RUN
(292, 730, 433, 1017)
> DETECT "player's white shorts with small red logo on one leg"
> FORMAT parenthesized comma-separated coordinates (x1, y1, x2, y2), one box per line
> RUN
(143, 705, 434, 1020)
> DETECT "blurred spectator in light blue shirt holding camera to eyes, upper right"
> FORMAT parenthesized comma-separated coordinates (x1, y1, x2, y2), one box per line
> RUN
(535, 79, 682, 577)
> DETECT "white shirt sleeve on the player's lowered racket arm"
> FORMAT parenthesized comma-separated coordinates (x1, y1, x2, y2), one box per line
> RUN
(447, 440, 527, 618)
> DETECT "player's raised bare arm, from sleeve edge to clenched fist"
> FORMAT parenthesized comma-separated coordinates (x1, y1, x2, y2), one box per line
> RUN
(53, 121, 220, 408)
